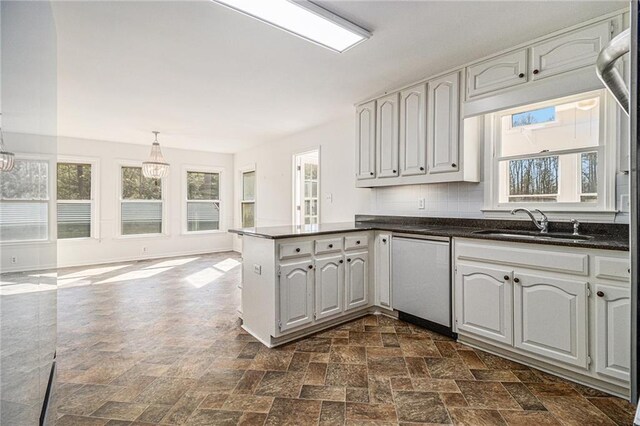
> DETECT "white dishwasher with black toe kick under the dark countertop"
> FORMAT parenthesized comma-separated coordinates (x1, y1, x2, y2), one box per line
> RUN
(391, 234, 452, 335)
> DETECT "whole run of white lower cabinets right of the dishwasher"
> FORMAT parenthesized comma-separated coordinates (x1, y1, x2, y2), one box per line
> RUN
(453, 238, 631, 396)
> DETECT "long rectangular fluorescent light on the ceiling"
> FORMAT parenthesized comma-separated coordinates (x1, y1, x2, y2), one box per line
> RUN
(212, 0, 371, 52)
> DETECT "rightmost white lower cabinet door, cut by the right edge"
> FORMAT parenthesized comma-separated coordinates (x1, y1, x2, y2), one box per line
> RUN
(595, 284, 631, 381)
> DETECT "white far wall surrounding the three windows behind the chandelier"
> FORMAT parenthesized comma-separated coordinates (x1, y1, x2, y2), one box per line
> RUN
(58, 134, 233, 267)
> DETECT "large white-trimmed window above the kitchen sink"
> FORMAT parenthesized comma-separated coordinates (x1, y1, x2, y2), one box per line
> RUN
(491, 91, 615, 211)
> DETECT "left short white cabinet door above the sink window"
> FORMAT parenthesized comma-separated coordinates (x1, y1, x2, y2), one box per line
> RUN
(467, 49, 528, 99)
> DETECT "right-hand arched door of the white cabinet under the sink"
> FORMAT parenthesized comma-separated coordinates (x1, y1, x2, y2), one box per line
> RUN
(514, 271, 588, 369)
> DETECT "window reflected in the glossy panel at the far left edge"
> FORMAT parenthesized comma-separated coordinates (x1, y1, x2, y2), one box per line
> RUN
(0, 159, 49, 242)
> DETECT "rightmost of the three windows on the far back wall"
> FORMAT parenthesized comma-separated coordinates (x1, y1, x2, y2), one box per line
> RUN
(186, 171, 220, 232)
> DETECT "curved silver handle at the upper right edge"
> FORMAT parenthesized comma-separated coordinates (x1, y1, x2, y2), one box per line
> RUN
(596, 28, 631, 115)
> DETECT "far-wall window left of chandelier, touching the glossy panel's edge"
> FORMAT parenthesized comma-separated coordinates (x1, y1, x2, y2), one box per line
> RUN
(56, 162, 93, 239)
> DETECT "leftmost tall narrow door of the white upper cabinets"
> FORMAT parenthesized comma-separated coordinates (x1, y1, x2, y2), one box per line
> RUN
(356, 101, 376, 179)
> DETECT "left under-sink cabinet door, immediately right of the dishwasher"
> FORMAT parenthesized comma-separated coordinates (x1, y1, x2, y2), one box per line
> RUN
(455, 264, 513, 345)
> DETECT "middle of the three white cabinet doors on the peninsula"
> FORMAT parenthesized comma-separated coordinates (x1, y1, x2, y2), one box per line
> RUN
(315, 256, 344, 319)
